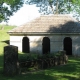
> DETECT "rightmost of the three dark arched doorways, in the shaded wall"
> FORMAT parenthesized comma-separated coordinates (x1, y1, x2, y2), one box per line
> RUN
(64, 37, 72, 55)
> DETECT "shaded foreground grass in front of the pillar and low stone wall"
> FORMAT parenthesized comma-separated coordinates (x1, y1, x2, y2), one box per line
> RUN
(0, 57, 80, 80)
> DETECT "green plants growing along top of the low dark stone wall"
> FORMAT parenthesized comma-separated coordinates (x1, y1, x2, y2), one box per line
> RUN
(19, 52, 63, 62)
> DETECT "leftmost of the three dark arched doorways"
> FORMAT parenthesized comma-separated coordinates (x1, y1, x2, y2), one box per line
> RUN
(22, 37, 30, 53)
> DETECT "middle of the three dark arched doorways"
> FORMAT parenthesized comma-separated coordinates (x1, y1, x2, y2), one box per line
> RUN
(42, 37, 50, 54)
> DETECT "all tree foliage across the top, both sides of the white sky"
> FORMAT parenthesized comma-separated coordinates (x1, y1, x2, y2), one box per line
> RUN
(0, 0, 80, 22)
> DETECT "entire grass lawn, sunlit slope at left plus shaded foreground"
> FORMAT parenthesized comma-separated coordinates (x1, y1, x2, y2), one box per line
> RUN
(0, 27, 80, 80)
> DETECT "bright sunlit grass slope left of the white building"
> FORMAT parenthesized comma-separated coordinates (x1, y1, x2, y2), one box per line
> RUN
(0, 25, 15, 55)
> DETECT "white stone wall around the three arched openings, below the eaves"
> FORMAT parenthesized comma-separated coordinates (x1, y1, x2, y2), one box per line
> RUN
(10, 35, 80, 55)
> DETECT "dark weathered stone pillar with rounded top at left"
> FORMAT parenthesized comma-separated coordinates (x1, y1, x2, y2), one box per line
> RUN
(4, 45, 18, 76)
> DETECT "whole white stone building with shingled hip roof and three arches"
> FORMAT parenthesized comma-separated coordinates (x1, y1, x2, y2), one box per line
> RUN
(8, 15, 80, 55)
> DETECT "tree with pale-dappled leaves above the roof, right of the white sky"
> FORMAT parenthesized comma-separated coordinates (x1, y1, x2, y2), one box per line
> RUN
(26, 0, 80, 20)
